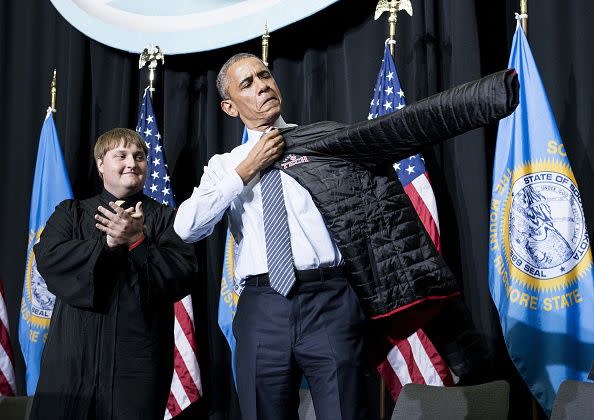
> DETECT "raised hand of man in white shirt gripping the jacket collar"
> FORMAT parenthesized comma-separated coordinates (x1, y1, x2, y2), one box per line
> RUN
(235, 128, 285, 185)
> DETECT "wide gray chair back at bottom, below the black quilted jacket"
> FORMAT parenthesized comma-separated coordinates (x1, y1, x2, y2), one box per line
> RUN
(392, 381, 509, 420)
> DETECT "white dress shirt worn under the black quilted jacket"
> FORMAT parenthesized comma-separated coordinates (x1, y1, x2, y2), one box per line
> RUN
(174, 117, 342, 287)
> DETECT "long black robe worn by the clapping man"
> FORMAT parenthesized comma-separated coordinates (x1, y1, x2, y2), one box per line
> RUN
(31, 191, 197, 420)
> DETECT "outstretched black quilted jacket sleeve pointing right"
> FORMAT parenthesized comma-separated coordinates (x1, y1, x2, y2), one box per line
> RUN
(298, 70, 519, 164)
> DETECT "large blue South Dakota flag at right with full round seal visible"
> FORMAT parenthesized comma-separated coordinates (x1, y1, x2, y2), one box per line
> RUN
(489, 26, 594, 414)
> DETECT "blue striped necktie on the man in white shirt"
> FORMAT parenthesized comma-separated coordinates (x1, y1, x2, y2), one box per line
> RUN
(260, 168, 295, 296)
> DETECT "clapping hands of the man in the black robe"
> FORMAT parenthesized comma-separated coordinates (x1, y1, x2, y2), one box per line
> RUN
(95, 202, 144, 248)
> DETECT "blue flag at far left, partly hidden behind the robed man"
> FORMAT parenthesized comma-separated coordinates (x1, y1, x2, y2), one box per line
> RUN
(19, 109, 72, 395)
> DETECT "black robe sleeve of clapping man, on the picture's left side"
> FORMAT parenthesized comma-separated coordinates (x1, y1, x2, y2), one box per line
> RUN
(34, 200, 125, 309)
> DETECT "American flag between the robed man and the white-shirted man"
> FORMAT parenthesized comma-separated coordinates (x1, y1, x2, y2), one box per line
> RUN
(136, 87, 202, 419)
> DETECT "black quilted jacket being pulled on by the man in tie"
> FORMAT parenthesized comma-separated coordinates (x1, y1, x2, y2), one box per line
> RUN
(275, 70, 518, 318)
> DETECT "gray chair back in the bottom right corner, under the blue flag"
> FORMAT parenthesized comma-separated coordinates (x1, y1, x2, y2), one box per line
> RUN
(551, 380, 594, 420)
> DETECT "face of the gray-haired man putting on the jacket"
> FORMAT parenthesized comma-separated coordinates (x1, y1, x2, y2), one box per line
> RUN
(221, 57, 282, 130)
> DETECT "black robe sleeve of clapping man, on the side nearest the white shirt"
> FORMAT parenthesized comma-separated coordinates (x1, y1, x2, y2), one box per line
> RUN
(129, 207, 198, 302)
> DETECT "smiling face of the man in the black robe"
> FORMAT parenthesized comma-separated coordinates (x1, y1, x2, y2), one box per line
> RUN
(97, 141, 146, 198)
